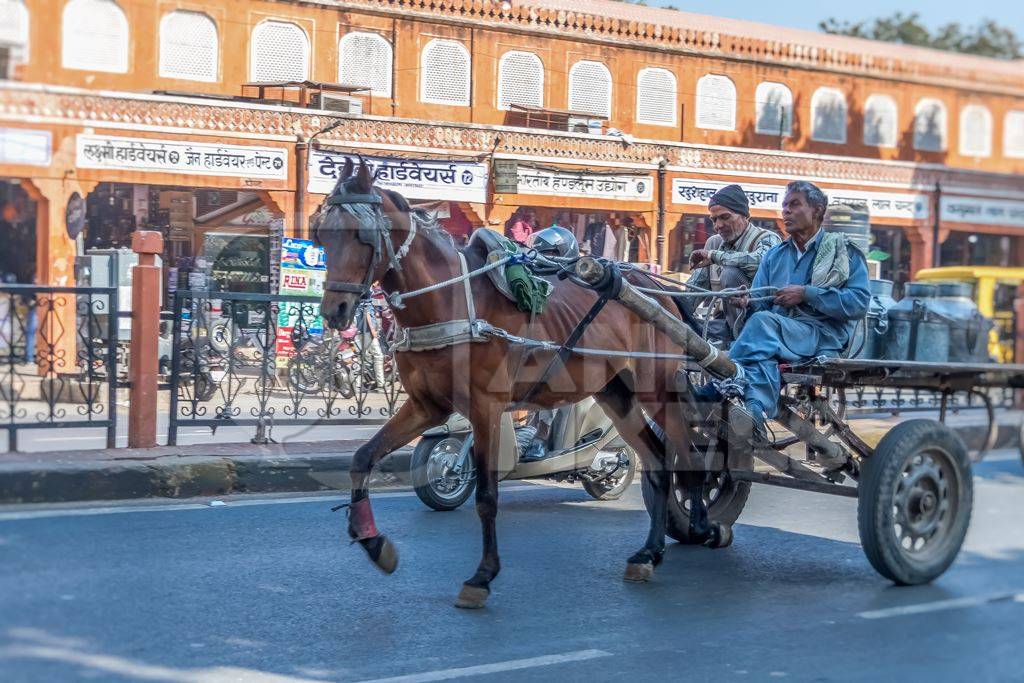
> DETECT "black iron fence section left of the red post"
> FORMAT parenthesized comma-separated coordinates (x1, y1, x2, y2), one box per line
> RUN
(0, 285, 119, 451)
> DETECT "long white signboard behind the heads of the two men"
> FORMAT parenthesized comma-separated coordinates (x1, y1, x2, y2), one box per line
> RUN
(672, 178, 930, 220)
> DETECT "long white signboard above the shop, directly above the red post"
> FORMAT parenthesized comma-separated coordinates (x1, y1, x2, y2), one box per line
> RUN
(75, 133, 288, 180)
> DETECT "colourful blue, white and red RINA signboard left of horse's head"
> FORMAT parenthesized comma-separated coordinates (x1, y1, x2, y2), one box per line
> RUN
(275, 238, 327, 368)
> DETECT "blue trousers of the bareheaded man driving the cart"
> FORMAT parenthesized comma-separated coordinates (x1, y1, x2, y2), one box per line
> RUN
(729, 311, 835, 418)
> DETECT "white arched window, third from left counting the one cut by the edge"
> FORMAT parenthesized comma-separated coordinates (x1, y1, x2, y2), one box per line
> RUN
(160, 11, 218, 83)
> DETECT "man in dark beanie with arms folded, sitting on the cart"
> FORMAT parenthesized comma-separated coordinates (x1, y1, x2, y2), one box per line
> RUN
(687, 185, 782, 346)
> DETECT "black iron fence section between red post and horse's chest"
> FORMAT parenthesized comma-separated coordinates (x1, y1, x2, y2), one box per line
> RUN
(162, 291, 402, 445)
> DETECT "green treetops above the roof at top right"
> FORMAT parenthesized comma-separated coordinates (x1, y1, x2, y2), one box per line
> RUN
(818, 11, 1024, 59)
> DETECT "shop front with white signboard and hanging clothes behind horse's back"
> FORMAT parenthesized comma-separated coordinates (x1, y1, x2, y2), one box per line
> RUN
(490, 160, 659, 270)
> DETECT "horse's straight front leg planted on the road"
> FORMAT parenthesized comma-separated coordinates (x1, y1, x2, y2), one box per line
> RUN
(455, 404, 502, 609)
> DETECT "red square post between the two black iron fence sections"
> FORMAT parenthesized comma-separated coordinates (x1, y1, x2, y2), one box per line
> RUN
(128, 230, 164, 449)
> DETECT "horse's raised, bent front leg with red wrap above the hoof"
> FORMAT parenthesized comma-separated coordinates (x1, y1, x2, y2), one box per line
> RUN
(348, 398, 447, 573)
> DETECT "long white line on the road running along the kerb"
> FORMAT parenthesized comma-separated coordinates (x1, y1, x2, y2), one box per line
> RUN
(0, 483, 552, 522)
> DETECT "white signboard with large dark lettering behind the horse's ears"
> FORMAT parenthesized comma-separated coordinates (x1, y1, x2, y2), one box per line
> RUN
(306, 150, 487, 204)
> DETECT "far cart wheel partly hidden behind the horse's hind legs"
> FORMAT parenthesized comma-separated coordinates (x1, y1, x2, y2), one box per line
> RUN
(640, 448, 754, 545)
